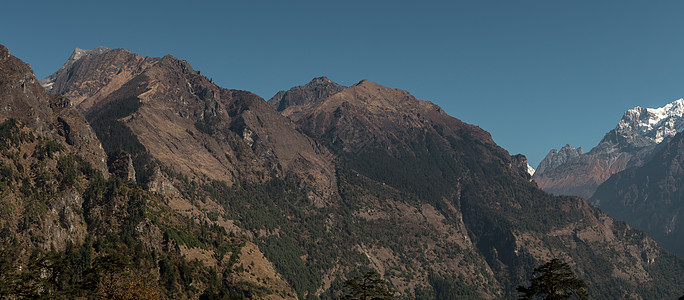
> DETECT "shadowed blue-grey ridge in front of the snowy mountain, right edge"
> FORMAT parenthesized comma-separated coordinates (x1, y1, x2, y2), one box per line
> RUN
(591, 133, 684, 256)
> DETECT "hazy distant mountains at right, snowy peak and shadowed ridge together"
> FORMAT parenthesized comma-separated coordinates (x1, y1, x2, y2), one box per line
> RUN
(534, 99, 684, 255)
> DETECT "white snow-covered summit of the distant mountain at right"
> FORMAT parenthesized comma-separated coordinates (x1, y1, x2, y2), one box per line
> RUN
(617, 99, 684, 143)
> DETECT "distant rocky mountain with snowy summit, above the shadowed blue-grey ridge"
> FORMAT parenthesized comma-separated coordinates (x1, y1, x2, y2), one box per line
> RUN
(533, 99, 684, 199)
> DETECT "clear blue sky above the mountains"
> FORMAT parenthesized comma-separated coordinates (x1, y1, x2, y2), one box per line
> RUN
(0, 0, 684, 167)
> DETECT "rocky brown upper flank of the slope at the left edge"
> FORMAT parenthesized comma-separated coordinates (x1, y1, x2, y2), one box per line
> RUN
(0, 45, 107, 174)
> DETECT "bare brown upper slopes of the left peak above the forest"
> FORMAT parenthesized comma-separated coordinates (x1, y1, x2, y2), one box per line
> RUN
(44, 49, 335, 199)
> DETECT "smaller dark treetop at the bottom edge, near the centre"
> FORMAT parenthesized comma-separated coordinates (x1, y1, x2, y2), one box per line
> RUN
(342, 271, 394, 300)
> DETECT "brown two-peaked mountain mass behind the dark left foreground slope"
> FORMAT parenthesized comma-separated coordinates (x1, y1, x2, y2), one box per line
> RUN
(38, 49, 684, 299)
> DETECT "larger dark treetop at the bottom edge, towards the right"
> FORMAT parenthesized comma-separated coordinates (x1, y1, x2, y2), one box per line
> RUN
(517, 258, 589, 300)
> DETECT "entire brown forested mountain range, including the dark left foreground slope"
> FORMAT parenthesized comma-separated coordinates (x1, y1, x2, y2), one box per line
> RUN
(0, 47, 684, 299)
